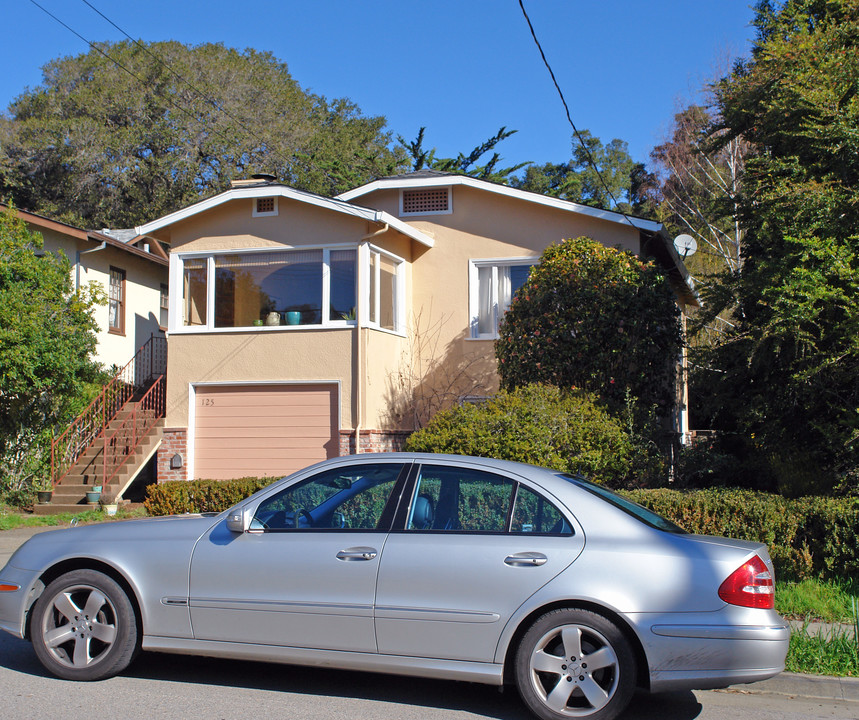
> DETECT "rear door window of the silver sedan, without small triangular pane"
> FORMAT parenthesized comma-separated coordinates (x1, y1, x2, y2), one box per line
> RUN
(406, 465, 516, 532)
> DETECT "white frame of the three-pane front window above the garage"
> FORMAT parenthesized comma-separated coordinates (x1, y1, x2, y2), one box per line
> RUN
(167, 243, 361, 334)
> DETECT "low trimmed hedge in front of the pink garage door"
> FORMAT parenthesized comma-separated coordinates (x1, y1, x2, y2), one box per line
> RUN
(143, 477, 278, 515)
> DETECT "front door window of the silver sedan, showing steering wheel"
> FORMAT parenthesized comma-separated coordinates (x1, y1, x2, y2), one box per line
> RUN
(251, 463, 403, 531)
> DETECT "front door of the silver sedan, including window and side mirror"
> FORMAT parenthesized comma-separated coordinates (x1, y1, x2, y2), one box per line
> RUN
(189, 462, 406, 652)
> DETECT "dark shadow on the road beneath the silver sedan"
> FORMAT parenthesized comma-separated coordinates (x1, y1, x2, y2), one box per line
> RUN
(0, 634, 702, 720)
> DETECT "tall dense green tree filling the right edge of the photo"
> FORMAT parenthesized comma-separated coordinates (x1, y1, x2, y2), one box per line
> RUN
(705, 0, 859, 492)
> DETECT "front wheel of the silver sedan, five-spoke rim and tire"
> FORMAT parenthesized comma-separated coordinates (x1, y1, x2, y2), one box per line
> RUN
(30, 570, 138, 680)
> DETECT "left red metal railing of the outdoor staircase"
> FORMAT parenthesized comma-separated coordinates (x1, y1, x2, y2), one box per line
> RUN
(51, 335, 167, 485)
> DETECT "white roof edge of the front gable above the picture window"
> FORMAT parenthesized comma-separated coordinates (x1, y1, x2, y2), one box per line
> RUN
(134, 182, 434, 248)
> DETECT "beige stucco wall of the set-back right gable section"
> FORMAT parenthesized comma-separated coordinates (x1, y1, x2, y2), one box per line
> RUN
(357, 186, 640, 422)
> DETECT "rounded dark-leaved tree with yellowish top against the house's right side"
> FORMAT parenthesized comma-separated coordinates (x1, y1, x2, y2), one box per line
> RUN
(495, 237, 681, 415)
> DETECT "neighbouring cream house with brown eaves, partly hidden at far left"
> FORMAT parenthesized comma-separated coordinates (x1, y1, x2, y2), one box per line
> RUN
(0, 205, 167, 369)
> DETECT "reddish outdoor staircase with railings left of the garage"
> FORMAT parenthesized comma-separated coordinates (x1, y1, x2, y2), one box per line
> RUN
(44, 336, 167, 515)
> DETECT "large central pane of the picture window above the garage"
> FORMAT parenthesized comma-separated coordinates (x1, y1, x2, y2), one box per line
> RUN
(215, 250, 322, 327)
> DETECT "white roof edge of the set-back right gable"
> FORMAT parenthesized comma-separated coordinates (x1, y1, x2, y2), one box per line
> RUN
(337, 170, 662, 232)
